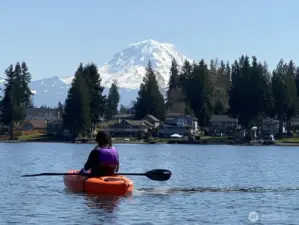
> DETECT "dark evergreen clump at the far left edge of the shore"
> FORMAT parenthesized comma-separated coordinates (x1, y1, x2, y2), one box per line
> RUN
(0, 62, 33, 138)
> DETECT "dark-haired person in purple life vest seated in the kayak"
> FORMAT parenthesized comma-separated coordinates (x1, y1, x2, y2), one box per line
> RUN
(80, 130, 119, 176)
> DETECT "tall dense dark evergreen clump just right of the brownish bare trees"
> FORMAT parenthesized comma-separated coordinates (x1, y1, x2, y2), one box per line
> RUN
(230, 56, 271, 128)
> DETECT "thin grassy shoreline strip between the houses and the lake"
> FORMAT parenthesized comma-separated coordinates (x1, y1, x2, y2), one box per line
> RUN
(0, 134, 299, 146)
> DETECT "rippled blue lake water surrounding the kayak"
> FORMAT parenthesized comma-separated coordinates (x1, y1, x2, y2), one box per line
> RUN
(0, 143, 299, 225)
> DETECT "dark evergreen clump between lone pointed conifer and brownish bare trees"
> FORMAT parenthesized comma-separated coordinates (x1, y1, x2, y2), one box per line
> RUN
(161, 60, 213, 126)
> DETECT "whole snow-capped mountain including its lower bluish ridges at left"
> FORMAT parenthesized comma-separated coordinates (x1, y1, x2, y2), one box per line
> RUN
(0, 40, 191, 107)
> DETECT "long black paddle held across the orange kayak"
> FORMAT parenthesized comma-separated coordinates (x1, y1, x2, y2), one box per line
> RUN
(21, 169, 171, 181)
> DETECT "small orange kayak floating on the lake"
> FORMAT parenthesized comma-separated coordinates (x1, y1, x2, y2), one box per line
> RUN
(63, 170, 134, 195)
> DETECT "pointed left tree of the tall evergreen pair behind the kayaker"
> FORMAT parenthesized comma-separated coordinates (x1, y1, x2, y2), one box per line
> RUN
(63, 64, 91, 139)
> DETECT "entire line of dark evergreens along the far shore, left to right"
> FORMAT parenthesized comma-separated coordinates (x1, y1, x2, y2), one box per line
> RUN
(0, 55, 299, 137)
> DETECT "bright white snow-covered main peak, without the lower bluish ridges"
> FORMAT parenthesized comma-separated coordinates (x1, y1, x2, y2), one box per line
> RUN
(99, 39, 192, 89)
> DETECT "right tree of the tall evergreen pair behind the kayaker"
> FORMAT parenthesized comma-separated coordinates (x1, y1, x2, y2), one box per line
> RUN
(83, 63, 107, 130)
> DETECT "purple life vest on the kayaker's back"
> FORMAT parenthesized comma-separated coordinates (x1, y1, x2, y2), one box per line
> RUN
(96, 147, 119, 167)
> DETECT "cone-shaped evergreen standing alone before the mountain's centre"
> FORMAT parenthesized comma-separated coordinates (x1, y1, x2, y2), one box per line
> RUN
(134, 61, 165, 120)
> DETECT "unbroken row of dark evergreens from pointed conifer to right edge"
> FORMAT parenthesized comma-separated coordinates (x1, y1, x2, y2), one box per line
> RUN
(134, 55, 299, 137)
